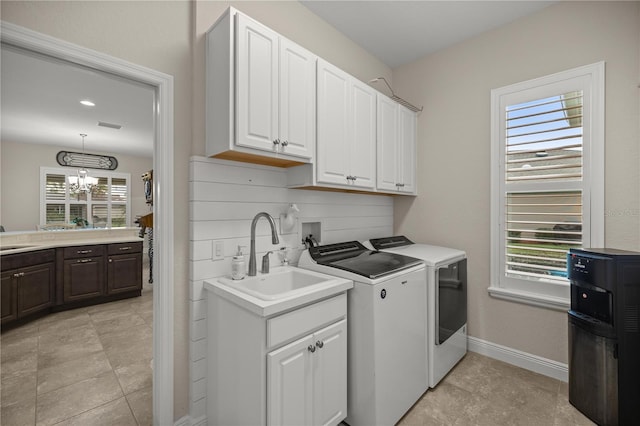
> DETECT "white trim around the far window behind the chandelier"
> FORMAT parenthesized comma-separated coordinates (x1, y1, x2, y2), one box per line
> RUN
(40, 167, 131, 229)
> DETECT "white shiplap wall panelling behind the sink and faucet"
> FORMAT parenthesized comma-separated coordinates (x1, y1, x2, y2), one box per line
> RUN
(189, 157, 393, 420)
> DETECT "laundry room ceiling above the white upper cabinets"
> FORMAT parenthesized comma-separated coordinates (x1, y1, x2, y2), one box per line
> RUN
(300, 0, 556, 68)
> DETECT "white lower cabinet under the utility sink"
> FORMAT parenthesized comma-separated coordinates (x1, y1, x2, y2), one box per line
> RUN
(207, 292, 347, 426)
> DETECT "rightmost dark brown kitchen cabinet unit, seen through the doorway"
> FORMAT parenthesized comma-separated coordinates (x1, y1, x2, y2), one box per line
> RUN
(107, 242, 142, 294)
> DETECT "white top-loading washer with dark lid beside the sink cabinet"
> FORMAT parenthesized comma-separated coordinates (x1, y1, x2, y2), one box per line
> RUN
(298, 241, 428, 426)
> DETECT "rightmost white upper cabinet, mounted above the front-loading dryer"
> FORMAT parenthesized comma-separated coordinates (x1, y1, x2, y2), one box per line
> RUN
(376, 94, 416, 194)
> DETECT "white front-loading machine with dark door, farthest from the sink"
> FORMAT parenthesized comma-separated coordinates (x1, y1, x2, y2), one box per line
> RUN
(364, 236, 467, 388)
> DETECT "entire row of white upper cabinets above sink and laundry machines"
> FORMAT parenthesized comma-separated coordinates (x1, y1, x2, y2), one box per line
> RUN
(205, 7, 416, 195)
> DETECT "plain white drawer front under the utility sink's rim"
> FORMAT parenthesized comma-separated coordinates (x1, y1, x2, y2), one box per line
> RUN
(267, 293, 347, 348)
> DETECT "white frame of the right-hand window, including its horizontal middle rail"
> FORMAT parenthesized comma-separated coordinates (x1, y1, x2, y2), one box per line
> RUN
(488, 62, 605, 310)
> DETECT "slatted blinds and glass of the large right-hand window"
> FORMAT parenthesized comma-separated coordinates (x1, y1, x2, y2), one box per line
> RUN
(504, 91, 583, 280)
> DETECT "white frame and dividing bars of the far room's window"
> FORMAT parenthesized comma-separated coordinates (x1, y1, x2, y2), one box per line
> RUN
(40, 167, 131, 229)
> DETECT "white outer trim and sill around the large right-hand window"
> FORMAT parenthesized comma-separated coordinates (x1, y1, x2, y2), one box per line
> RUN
(488, 62, 605, 310)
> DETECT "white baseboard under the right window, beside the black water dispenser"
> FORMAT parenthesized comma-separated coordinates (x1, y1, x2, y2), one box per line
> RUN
(467, 336, 569, 382)
